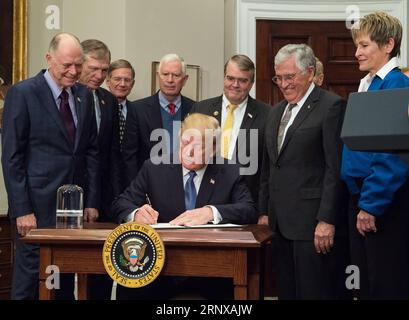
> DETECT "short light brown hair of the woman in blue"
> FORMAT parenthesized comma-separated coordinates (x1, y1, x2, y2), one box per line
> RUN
(351, 11, 402, 58)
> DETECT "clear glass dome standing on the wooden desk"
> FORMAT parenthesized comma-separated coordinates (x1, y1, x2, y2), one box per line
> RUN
(56, 184, 84, 229)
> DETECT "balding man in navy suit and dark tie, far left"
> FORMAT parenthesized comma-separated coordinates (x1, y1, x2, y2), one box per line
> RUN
(2, 33, 99, 299)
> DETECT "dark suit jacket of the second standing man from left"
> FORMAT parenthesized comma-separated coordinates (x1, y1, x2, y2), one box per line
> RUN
(96, 88, 121, 221)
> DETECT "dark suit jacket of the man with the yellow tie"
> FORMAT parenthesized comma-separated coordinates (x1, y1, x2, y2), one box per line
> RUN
(191, 96, 271, 204)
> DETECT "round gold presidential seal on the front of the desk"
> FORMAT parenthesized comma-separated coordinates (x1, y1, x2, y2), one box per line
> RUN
(102, 222, 165, 288)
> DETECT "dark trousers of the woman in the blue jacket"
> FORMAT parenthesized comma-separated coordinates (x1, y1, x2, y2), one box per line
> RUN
(349, 188, 409, 299)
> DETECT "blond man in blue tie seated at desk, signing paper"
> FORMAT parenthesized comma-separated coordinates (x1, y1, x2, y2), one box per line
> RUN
(113, 114, 257, 299)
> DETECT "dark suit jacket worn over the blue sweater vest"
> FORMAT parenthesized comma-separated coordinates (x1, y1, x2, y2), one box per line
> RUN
(122, 93, 194, 186)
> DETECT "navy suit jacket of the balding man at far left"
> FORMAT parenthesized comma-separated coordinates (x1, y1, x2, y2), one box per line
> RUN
(2, 71, 99, 228)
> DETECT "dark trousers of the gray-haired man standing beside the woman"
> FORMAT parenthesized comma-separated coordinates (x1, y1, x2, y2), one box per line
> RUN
(273, 231, 350, 300)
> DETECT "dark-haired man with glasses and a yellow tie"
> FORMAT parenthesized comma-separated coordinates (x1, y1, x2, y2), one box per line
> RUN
(192, 54, 271, 203)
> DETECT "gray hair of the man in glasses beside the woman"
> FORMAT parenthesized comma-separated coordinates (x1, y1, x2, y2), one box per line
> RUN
(274, 43, 316, 72)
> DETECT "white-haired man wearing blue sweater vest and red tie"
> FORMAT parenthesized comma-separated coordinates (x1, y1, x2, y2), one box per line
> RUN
(122, 53, 193, 185)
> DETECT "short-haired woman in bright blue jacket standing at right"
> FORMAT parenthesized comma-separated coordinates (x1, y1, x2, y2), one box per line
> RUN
(341, 12, 409, 299)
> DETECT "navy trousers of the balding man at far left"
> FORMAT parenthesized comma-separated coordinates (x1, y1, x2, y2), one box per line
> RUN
(11, 238, 74, 300)
